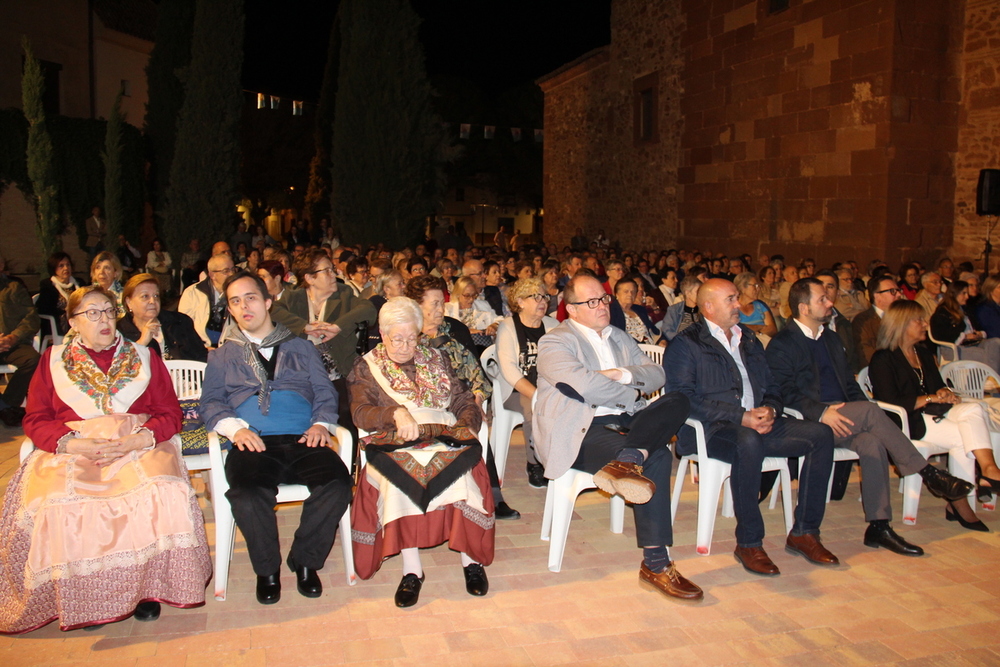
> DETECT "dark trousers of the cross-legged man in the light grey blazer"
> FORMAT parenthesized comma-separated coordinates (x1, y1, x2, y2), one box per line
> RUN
(572, 392, 691, 547)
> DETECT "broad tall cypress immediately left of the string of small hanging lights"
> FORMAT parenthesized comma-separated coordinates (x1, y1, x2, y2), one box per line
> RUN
(163, 0, 244, 249)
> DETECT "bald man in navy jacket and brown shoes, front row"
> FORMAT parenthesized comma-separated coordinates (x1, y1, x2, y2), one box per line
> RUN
(663, 279, 839, 576)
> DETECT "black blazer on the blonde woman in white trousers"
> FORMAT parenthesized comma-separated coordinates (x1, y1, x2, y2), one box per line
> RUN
(868, 345, 946, 440)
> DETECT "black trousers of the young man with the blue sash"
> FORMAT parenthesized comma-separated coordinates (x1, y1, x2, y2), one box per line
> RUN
(226, 435, 351, 576)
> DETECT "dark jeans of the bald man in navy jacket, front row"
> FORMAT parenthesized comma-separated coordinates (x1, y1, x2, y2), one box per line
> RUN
(706, 417, 833, 547)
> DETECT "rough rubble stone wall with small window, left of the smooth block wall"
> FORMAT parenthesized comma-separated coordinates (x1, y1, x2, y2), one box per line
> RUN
(540, 0, 684, 248)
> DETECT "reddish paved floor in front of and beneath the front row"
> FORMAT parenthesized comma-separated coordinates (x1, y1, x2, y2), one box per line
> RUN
(0, 426, 1000, 667)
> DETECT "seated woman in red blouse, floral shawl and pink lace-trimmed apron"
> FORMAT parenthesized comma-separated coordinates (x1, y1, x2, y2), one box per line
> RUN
(0, 285, 212, 633)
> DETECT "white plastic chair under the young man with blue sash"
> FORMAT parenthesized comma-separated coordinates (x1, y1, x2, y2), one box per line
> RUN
(208, 426, 357, 601)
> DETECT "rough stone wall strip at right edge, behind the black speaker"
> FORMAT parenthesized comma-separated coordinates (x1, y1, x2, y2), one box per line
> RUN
(953, 0, 1000, 271)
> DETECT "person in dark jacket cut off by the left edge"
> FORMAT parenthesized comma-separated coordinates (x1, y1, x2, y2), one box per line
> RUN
(0, 257, 39, 427)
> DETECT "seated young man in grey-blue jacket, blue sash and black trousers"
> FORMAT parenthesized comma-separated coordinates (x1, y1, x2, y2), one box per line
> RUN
(201, 272, 351, 604)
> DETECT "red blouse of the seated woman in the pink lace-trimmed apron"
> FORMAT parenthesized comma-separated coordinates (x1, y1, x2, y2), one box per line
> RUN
(23, 347, 181, 453)
